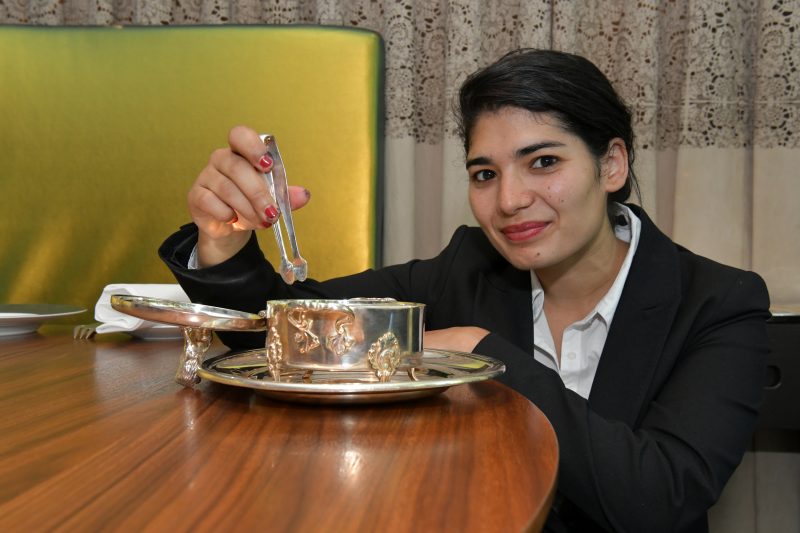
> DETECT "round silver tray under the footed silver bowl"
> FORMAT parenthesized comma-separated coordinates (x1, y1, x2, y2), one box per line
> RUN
(197, 349, 505, 404)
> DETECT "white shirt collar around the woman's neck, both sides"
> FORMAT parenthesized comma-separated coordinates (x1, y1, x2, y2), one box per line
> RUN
(531, 202, 642, 326)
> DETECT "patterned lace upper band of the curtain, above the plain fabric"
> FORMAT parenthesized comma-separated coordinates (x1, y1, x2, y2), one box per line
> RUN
(0, 0, 800, 144)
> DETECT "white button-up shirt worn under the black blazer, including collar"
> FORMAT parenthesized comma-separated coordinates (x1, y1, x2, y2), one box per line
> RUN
(531, 204, 642, 399)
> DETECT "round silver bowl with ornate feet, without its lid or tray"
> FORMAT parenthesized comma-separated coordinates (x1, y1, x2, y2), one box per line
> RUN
(264, 298, 425, 381)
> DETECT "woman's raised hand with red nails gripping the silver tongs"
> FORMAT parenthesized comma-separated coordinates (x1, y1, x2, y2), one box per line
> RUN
(188, 126, 310, 267)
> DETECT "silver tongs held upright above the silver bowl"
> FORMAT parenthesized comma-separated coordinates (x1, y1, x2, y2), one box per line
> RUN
(261, 133, 308, 284)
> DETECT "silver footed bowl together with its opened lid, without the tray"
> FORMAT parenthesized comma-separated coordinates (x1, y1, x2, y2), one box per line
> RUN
(111, 294, 432, 387)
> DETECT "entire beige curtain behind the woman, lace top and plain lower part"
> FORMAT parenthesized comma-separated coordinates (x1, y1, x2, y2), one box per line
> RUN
(0, 0, 800, 303)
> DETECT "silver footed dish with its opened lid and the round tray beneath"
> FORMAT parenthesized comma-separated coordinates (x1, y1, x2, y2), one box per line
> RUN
(111, 294, 505, 404)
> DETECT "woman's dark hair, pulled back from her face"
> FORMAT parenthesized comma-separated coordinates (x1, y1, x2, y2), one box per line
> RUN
(457, 48, 641, 205)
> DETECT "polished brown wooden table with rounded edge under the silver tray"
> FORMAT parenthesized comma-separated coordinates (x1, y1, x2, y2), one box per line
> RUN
(0, 327, 558, 532)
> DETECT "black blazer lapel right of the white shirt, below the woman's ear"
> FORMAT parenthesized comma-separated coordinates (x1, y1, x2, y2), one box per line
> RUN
(589, 206, 681, 426)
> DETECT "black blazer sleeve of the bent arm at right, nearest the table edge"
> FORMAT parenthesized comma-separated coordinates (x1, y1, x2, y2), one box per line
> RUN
(475, 272, 769, 531)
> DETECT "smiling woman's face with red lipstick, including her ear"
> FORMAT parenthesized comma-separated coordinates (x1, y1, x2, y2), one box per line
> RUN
(467, 107, 628, 270)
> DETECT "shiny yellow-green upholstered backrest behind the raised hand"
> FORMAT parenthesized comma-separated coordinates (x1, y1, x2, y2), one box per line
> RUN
(0, 26, 383, 307)
